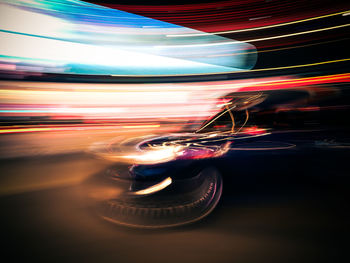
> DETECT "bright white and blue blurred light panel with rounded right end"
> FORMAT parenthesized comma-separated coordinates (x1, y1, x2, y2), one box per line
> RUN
(0, 0, 256, 76)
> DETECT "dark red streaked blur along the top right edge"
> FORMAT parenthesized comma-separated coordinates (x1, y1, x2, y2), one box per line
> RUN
(102, 0, 349, 34)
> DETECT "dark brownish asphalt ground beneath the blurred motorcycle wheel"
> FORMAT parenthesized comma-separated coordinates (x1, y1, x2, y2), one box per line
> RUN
(0, 140, 350, 263)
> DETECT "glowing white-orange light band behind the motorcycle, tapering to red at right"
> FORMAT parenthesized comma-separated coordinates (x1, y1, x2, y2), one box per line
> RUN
(0, 73, 350, 122)
